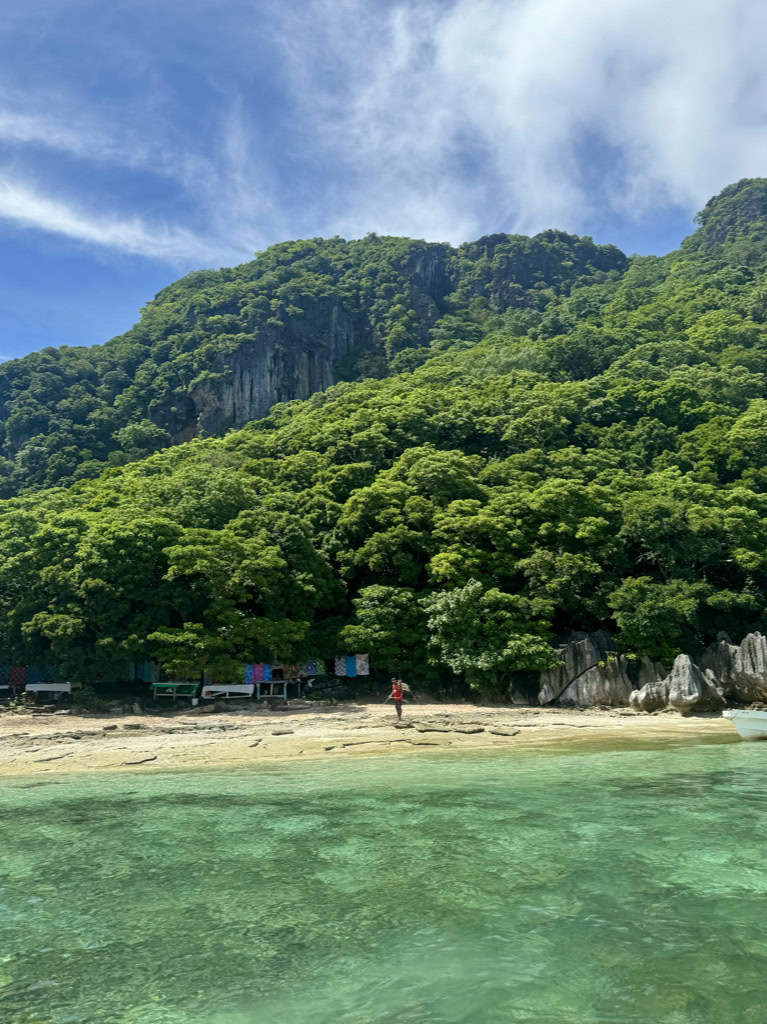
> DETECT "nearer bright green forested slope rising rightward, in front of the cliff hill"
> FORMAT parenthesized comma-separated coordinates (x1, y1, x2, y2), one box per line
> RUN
(0, 180, 767, 690)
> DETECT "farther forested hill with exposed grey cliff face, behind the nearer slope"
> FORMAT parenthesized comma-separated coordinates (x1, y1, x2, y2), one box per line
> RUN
(0, 230, 628, 497)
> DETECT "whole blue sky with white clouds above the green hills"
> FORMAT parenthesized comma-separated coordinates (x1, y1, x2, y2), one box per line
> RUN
(0, 0, 767, 358)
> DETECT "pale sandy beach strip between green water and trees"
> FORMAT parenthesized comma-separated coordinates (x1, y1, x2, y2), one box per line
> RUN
(0, 702, 737, 777)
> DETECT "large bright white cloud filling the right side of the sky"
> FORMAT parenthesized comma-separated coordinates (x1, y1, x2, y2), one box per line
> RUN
(270, 0, 767, 240)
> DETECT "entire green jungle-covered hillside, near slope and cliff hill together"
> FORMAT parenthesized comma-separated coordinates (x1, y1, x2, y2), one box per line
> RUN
(0, 179, 767, 692)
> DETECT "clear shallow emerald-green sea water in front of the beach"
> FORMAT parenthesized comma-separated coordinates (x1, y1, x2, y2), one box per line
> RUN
(0, 743, 767, 1024)
